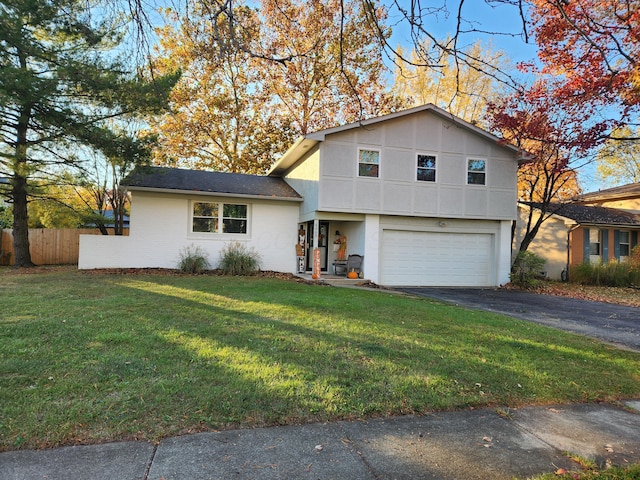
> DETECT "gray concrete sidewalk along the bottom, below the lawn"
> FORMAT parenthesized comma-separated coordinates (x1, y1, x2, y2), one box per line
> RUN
(0, 400, 640, 480)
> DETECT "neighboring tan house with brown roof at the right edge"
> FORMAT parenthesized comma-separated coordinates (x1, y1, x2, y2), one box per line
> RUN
(514, 183, 640, 280)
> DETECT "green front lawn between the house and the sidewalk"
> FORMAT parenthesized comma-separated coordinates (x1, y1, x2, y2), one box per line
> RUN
(0, 269, 640, 450)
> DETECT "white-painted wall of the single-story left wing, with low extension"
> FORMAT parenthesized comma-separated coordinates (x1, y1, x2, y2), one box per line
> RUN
(78, 192, 299, 272)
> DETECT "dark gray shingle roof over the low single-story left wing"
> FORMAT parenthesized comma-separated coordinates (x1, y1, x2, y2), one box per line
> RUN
(121, 167, 302, 201)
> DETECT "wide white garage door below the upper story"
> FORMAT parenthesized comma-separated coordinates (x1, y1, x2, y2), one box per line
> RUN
(381, 230, 494, 287)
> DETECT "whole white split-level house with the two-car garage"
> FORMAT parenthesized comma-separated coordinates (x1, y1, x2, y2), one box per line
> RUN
(79, 105, 519, 286)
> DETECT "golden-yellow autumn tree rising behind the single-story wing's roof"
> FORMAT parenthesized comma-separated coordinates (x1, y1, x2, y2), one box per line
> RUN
(153, 3, 292, 173)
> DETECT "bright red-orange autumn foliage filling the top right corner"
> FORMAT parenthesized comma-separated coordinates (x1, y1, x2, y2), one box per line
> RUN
(528, 0, 640, 134)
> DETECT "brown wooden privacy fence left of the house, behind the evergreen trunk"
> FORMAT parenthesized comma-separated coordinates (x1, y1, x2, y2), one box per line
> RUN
(0, 228, 129, 265)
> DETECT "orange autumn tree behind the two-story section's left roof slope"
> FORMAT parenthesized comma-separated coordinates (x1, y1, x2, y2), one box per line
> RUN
(260, 0, 393, 135)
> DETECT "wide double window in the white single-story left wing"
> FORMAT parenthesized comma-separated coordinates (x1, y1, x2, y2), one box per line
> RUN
(191, 202, 247, 234)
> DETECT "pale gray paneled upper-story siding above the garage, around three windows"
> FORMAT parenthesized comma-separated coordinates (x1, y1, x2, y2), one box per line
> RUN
(318, 111, 517, 220)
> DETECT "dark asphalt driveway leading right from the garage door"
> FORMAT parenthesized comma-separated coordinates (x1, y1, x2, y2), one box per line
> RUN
(397, 287, 640, 352)
